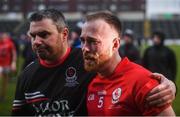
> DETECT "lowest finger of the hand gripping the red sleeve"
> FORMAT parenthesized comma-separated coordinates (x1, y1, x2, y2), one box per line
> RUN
(148, 95, 172, 107)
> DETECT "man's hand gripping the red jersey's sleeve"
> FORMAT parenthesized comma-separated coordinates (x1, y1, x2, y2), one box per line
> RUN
(146, 73, 176, 106)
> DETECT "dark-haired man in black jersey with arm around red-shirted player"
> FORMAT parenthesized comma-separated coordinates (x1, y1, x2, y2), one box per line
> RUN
(12, 9, 175, 116)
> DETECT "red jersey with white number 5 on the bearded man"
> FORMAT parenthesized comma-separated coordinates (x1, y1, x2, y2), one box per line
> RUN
(87, 58, 169, 116)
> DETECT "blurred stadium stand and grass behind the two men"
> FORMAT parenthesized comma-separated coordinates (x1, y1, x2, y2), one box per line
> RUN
(0, 0, 180, 115)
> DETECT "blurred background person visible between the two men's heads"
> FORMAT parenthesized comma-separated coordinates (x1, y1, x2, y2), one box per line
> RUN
(70, 26, 81, 48)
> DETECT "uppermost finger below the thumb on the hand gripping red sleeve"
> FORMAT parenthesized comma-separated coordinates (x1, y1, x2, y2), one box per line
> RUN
(148, 84, 169, 96)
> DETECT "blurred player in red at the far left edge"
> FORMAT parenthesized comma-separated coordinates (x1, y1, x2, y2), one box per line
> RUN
(0, 32, 17, 100)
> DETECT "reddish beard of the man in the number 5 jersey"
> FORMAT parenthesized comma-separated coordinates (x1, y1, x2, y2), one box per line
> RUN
(84, 49, 111, 72)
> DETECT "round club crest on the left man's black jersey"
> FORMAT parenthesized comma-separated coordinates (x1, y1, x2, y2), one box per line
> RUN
(65, 67, 79, 87)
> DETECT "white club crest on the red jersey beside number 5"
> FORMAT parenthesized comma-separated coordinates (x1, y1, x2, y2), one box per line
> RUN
(112, 88, 121, 104)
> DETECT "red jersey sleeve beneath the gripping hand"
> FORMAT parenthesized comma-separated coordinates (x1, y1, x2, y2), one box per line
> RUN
(135, 78, 170, 116)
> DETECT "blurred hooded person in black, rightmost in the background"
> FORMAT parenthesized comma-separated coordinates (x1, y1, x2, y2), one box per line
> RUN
(142, 31, 177, 82)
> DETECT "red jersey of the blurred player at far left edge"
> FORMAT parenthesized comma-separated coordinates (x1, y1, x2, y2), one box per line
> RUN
(0, 38, 15, 67)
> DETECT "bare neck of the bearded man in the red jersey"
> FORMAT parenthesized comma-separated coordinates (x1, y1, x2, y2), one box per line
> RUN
(98, 53, 121, 77)
